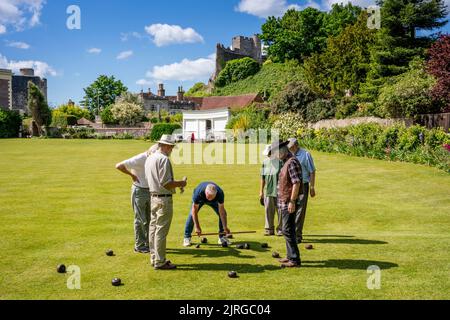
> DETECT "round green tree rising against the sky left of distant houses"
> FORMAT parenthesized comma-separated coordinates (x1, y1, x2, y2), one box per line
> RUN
(82, 75, 128, 114)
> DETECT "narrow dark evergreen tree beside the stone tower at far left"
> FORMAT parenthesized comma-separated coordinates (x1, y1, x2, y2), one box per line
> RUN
(27, 81, 52, 135)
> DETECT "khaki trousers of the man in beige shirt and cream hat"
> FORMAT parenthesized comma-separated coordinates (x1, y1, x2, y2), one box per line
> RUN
(149, 197, 173, 267)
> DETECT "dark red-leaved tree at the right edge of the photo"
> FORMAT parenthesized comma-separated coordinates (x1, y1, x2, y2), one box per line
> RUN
(427, 34, 450, 111)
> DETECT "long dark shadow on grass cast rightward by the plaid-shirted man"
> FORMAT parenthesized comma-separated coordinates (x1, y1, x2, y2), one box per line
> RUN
(302, 259, 398, 270)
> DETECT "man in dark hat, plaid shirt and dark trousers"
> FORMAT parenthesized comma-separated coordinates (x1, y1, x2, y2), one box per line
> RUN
(271, 141, 302, 268)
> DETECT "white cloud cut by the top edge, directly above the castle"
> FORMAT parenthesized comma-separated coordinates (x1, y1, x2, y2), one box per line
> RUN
(236, 0, 301, 18)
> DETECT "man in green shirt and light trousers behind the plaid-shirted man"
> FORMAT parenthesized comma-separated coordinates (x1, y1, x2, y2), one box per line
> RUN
(259, 145, 283, 236)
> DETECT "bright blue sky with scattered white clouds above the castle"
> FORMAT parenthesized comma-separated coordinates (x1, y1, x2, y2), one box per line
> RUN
(0, 0, 450, 106)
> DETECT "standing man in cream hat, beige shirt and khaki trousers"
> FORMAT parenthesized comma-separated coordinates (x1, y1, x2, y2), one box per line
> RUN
(145, 135, 187, 270)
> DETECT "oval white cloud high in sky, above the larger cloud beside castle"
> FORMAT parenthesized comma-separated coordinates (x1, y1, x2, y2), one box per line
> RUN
(145, 23, 203, 47)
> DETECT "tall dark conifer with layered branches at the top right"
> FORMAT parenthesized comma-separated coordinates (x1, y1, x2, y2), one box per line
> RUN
(361, 0, 447, 101)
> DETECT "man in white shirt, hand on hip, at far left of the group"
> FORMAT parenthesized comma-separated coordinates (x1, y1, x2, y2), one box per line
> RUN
(116, 145, 158, 253)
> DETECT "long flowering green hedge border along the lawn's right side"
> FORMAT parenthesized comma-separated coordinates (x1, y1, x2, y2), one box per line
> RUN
(297, 123, 450, 173)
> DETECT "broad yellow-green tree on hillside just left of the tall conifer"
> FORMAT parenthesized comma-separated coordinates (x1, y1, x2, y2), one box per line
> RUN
(304, 12, 375, 96)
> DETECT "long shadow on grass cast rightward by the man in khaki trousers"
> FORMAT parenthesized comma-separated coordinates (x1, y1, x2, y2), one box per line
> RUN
(177, 263, 281, 274)
